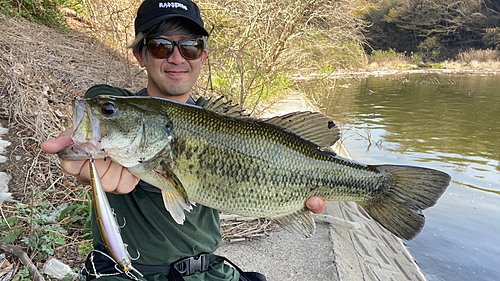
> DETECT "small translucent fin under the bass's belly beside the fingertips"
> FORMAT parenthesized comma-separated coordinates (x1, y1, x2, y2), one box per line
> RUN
(272, 207, 316, 238)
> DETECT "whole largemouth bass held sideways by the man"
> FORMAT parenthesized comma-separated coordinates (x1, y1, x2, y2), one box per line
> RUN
(59, 96, 450, 240)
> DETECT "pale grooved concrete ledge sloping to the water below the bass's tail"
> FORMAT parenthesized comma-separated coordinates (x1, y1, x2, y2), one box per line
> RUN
(327, 202, 427, 281)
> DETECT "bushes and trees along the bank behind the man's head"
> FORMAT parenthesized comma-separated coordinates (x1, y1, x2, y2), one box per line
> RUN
(0, 0, 500, 103)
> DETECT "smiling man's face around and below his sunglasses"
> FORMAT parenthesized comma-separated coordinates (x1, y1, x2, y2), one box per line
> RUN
(134, 35, 207, 102)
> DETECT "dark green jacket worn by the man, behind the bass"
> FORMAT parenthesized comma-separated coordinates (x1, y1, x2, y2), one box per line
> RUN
(85, 85, 239, 281)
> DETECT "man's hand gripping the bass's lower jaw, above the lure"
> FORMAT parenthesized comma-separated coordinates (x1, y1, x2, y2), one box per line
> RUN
(41, 130, 139, 194)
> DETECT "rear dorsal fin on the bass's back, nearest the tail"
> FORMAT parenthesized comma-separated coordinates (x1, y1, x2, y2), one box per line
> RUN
(264, 111, 340, 147)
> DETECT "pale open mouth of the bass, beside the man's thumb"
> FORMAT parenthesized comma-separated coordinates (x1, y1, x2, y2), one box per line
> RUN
(71, 98, 101, 150)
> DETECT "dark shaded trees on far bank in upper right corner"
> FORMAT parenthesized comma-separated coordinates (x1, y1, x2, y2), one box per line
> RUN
(364, 0, 500, 59)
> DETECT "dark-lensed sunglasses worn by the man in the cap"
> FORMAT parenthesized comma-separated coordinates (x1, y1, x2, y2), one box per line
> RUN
(144, 37, 205, 60)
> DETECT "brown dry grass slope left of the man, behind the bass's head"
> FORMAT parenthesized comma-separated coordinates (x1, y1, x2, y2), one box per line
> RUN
(0, 13, 146, 199)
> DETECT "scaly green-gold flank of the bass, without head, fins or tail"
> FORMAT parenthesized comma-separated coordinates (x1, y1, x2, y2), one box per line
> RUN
(151, 99, 382, 215)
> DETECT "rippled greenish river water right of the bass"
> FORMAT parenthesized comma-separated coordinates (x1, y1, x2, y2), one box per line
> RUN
(309, 74, 500, 281)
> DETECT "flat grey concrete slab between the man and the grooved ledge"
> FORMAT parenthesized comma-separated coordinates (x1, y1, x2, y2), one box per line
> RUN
(216, 223, 340, 281)
